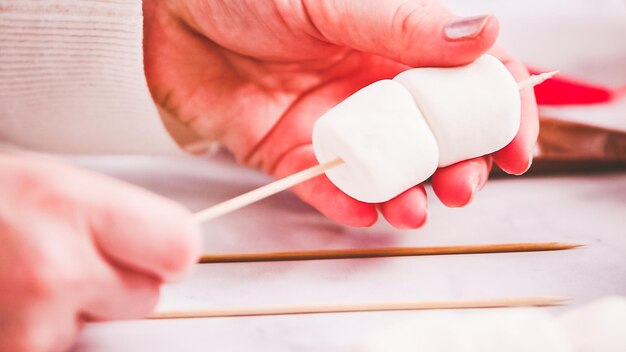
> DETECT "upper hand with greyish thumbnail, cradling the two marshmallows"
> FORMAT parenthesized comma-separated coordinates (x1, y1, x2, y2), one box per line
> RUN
(144, 0, 538, 228)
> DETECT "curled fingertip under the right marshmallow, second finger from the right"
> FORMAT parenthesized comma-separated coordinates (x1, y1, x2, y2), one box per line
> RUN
(431, 156, 491, 207)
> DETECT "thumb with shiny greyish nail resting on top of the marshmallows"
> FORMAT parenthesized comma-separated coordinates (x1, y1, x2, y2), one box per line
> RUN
(305, 0, 498, 67)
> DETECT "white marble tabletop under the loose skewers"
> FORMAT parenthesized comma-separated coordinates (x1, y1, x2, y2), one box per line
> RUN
(68, 156, 626, 352)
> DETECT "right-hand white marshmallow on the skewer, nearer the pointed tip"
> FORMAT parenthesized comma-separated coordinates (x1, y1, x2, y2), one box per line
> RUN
(394, 55, 521, 167)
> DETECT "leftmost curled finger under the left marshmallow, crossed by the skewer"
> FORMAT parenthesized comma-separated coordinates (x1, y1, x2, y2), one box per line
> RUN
(274, 145, 378, 227)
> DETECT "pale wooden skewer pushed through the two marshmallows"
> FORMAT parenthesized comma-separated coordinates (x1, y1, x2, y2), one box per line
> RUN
(194, 71, 558, 223)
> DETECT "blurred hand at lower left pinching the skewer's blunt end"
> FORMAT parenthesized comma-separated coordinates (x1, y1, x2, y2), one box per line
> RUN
(0, 155, 199, 352)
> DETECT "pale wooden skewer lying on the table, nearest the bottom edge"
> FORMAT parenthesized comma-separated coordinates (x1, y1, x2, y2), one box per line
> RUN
(148, 296, 571, 319)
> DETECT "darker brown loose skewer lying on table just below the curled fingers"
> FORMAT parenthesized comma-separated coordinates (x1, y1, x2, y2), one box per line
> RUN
(198, 242, 584, 264)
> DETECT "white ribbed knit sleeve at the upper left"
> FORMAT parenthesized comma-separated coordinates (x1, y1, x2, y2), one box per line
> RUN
(0, 0, 181, 154)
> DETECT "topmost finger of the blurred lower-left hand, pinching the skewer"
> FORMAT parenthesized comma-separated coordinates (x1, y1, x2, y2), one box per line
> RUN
(2, 158, 200, 281)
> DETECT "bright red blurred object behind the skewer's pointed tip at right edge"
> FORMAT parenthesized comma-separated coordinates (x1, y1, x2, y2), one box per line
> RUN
(530, 69, 624, 105)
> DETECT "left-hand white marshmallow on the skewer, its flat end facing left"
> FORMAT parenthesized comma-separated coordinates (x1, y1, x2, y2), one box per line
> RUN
(313, 80, 439, 203)
